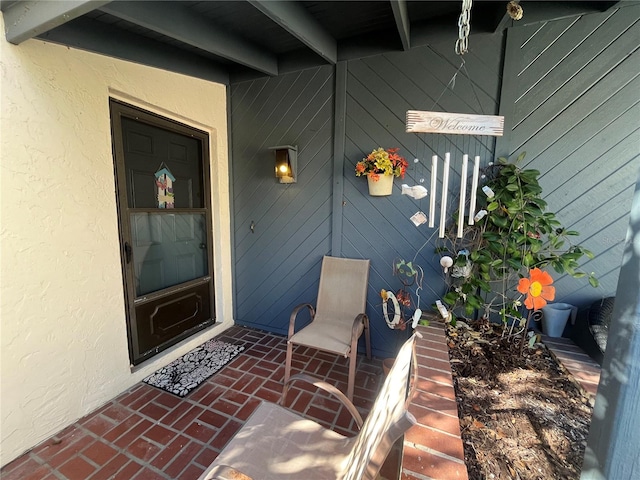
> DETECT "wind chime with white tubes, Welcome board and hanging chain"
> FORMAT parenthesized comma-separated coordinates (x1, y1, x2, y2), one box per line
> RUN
(402, 0, 504, 238)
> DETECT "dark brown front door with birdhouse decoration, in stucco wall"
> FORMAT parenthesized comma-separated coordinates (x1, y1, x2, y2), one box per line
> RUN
(110, 100, 214, 365)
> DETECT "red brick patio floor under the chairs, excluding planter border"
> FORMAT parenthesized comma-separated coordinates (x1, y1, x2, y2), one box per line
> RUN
(0, 327, 382, 480)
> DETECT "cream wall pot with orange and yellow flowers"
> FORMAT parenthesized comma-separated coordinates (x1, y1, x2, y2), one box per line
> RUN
(356, 147, 408, 197)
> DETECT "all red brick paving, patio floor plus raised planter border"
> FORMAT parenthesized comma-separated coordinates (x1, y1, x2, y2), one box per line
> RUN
(0, 321, 600, 480)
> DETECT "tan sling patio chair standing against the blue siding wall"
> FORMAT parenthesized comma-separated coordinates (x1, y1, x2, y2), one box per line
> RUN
(284, 256, 371, 401)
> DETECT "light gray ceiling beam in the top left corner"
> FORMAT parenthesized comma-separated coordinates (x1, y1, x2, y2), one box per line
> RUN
(2, 0, 109, 45)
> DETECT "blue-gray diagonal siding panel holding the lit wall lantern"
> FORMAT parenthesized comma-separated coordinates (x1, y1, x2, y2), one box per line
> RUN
(231, 67, 334, 333)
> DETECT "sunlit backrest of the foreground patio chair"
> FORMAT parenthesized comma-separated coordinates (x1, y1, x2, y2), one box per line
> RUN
(342, 333, 419, 480)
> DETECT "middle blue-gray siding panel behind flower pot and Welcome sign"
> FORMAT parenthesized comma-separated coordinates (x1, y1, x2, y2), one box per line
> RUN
(342, 39, 502, 355)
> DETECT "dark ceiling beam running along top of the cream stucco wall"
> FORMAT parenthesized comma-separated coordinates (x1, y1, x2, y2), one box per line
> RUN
(39, 18, 229, 84)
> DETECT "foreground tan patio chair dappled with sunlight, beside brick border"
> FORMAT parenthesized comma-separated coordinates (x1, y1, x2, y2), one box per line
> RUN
(199, 333, 420, 480)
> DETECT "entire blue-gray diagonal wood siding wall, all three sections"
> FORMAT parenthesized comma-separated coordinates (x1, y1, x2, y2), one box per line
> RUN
(230, 6, 640, 355)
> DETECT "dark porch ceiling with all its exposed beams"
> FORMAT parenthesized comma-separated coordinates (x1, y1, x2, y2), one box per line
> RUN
(0, 0, 618, 84)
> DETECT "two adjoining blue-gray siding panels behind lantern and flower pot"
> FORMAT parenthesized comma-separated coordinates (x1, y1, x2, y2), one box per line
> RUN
(231, 35, 503, 355)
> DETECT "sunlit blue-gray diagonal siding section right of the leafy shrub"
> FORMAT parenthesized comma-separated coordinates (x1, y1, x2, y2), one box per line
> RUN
(497, 5, 640, 308)
